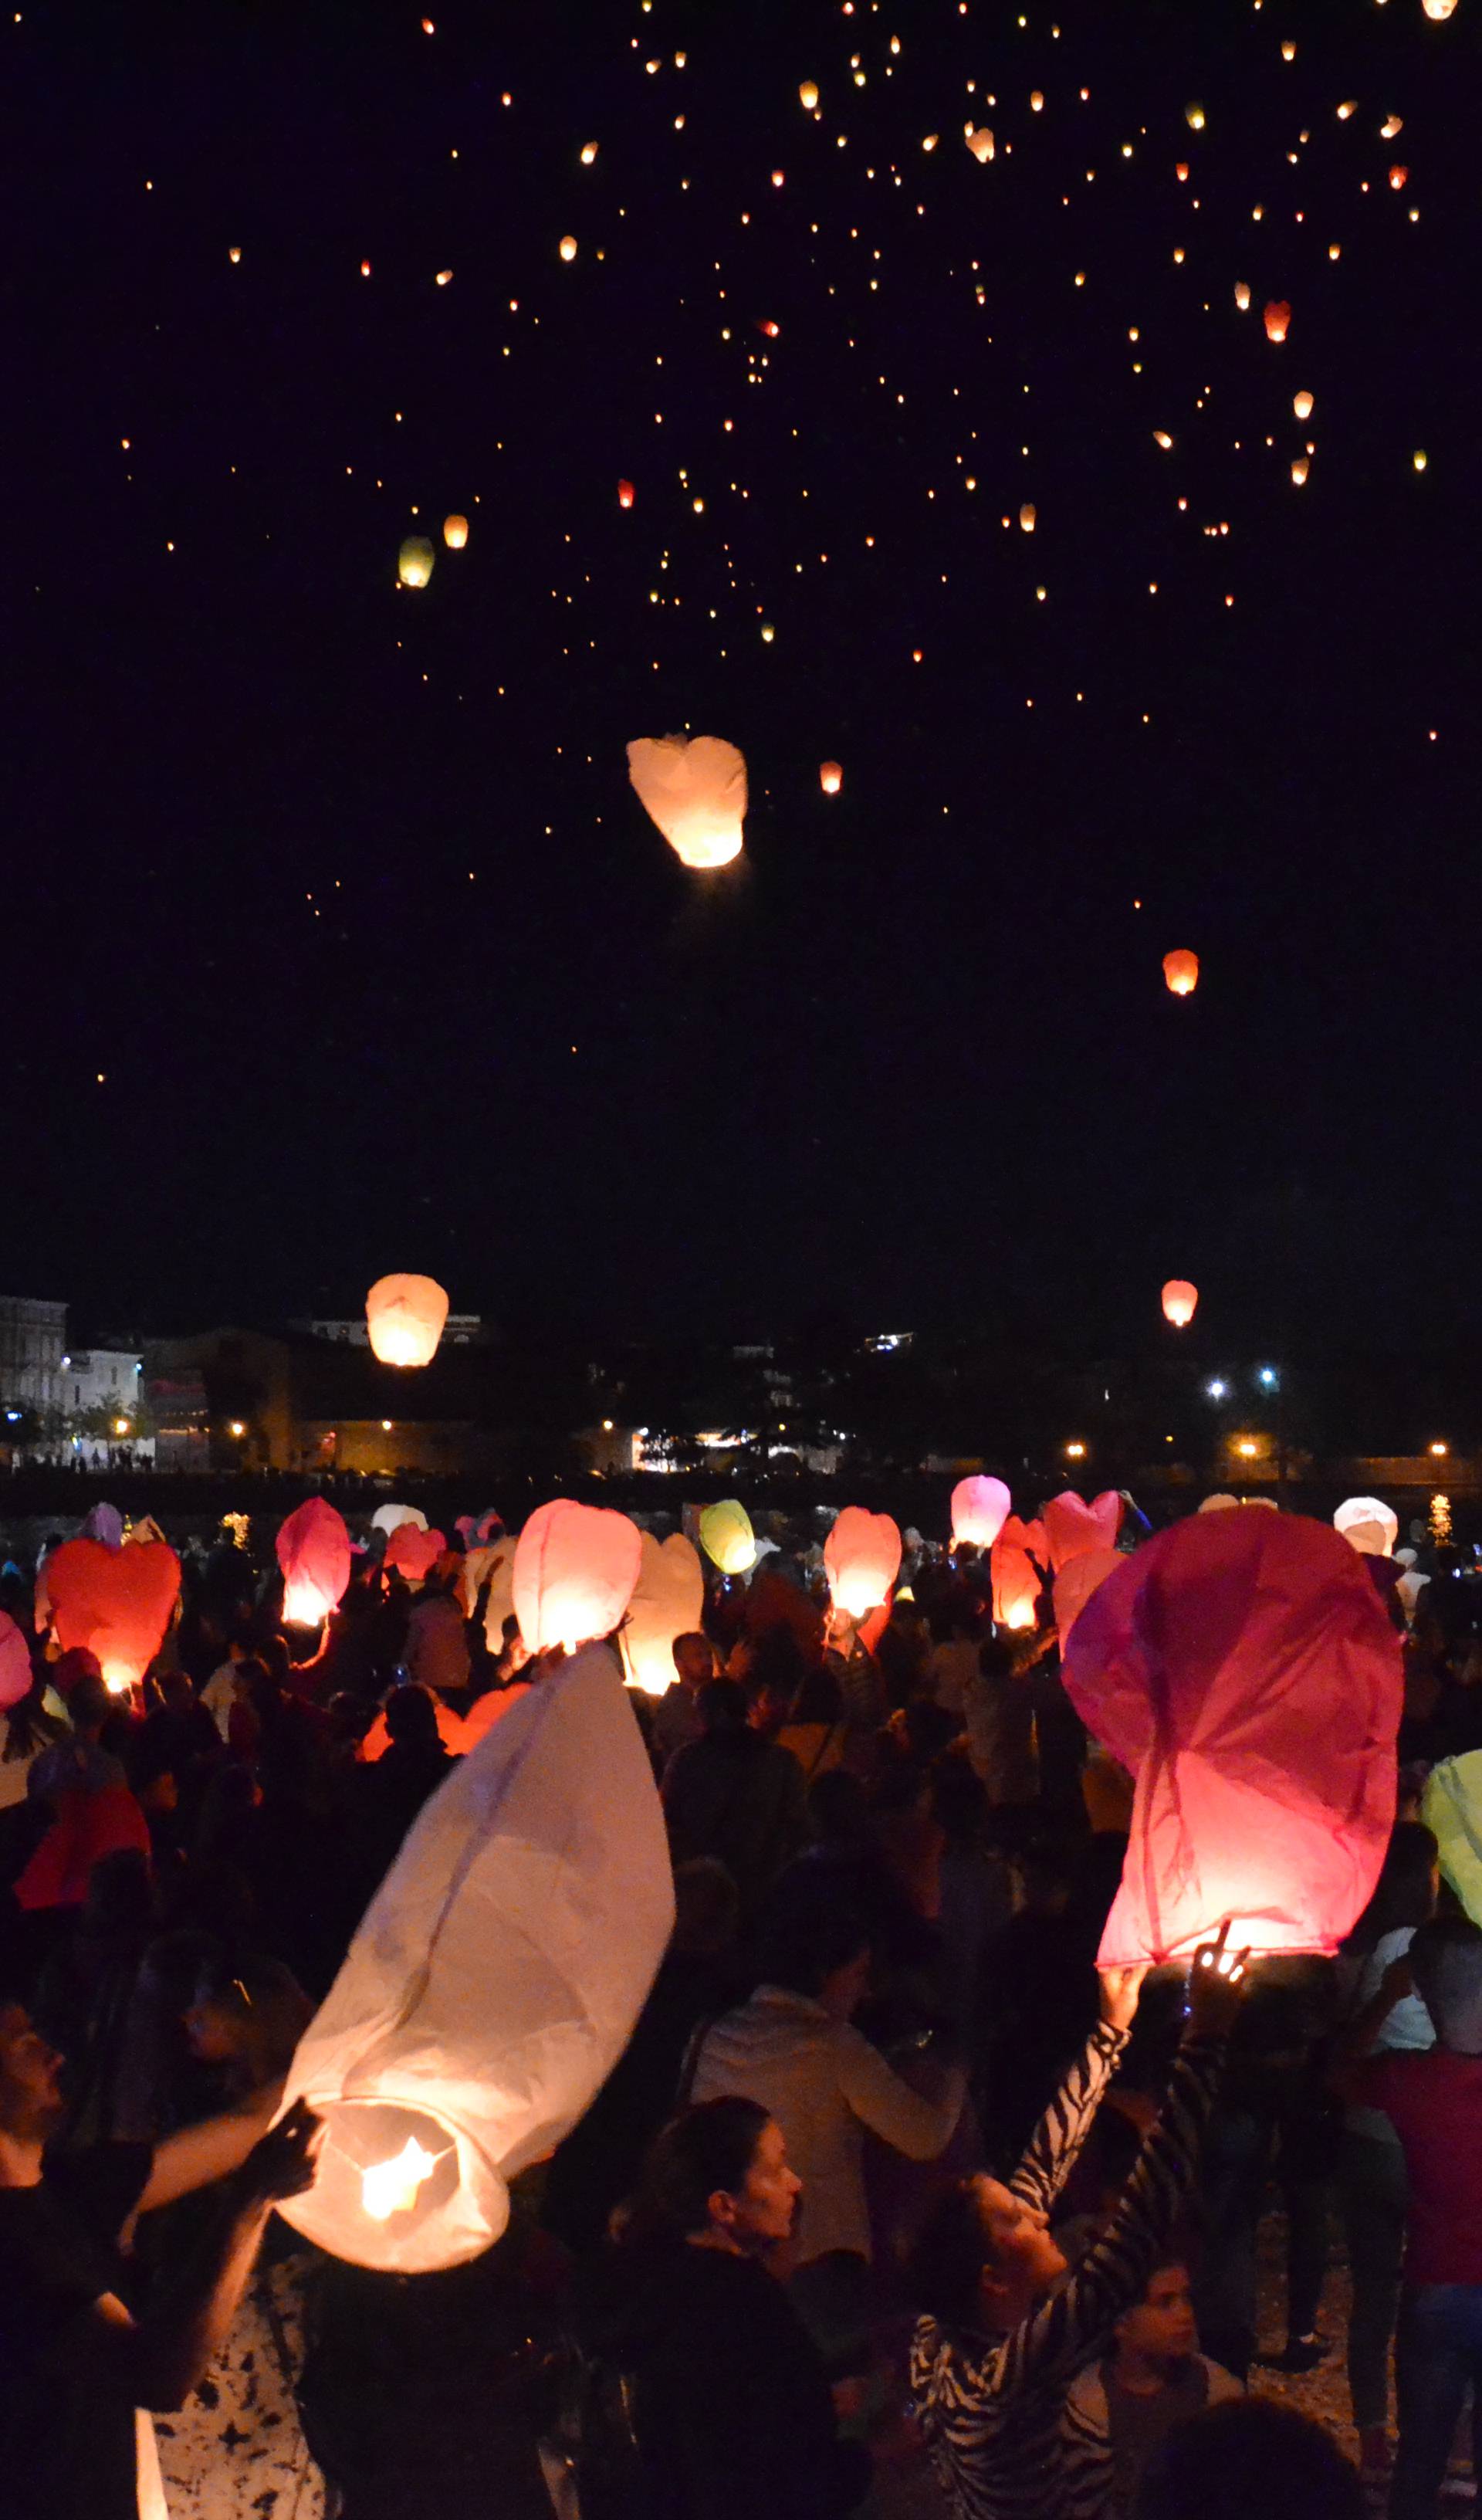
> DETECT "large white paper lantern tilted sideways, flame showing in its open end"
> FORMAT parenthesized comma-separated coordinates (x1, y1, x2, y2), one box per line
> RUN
(283, 1643, 673, 2275)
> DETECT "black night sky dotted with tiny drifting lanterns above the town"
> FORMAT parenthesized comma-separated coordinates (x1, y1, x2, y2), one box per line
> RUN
(0, 0, 1482, 1353)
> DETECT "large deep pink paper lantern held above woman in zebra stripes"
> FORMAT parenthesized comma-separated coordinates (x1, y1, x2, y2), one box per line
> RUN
(1064, 1512, 1404, 1968)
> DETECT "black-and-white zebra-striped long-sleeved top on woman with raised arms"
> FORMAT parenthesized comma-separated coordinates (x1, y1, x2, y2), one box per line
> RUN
(910, 2024, 1225, 2520)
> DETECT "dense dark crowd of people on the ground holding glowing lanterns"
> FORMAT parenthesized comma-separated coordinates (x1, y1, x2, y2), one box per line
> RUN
(0, 1492, 1482, 2520)
